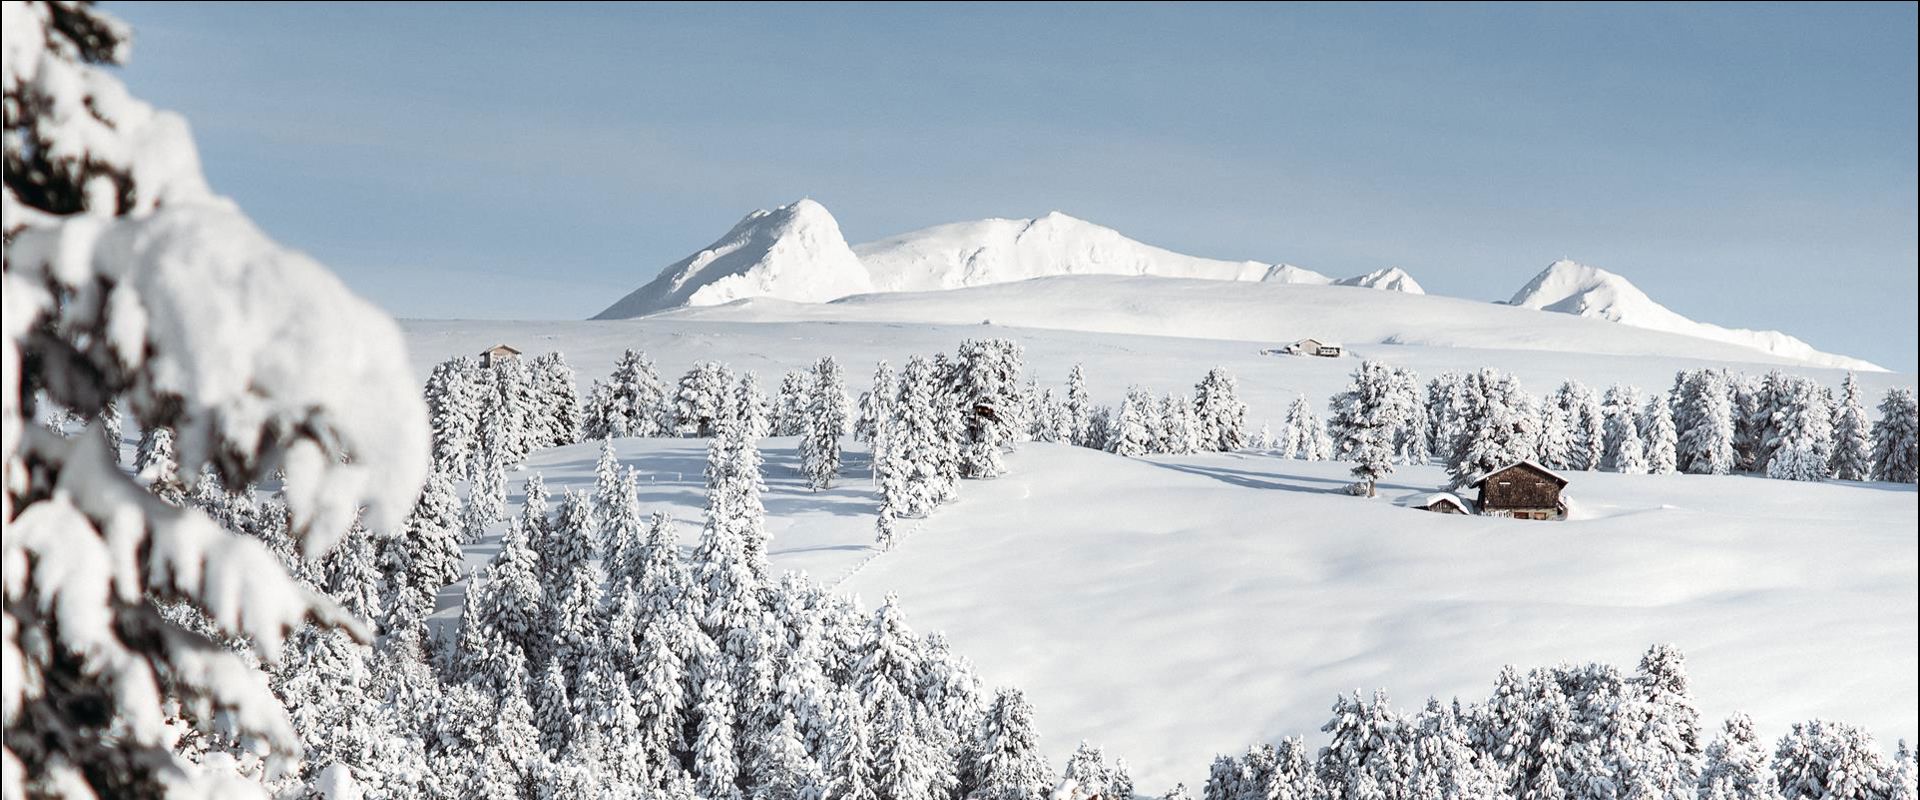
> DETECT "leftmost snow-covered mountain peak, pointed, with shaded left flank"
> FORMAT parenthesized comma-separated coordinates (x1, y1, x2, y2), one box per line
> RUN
(593, 200, 872, 318)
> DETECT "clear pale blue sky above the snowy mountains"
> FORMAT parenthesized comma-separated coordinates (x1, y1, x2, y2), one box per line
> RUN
(106, 2, 1920, 370)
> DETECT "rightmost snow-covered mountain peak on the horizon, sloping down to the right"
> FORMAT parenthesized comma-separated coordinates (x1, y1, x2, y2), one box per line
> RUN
(1507, 259, 1880, 370)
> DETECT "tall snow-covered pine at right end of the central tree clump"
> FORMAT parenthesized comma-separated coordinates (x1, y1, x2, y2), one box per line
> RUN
(947, 340, 1025, 478)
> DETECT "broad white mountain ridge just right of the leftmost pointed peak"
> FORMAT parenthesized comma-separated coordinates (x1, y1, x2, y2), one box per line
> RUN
(854, 211, 1297, 292)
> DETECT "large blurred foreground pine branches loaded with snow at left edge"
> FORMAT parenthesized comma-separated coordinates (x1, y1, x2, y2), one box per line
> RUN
(0, 2, 428, 798)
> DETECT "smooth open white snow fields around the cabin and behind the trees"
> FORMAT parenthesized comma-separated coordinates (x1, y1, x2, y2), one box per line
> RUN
(403, 314, 1920, 794)
